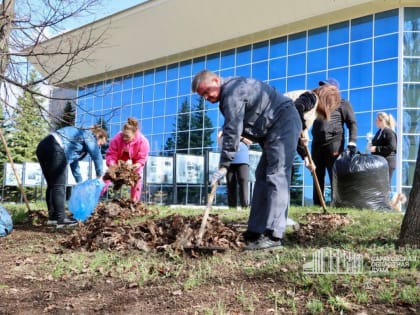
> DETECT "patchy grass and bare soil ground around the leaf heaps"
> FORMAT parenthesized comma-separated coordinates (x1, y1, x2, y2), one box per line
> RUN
(0, 204, 420, 314)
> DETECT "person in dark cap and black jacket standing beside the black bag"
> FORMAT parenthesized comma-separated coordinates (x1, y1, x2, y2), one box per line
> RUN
(311, 78, 357, 205)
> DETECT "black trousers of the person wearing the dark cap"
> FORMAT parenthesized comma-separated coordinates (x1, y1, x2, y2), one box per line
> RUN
(311, 141, 344, 206)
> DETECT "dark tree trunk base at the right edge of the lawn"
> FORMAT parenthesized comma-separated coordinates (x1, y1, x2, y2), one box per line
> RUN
(399, 146, 420, 248)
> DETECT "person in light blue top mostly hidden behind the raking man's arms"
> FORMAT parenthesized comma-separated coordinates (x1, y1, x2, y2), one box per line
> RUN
(218, 131, 252, 209)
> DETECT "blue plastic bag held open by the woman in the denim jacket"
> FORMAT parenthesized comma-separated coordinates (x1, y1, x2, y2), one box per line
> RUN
(68, 179, 104, 221)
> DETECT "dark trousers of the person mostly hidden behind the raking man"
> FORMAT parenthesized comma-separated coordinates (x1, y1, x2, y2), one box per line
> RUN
(226, 164, 249, 208)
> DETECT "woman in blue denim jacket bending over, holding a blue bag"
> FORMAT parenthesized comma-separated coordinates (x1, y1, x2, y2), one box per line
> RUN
(36, 126, 107, 228)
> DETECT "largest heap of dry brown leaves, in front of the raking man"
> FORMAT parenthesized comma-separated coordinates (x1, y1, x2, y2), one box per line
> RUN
(61, 200, 243, 252)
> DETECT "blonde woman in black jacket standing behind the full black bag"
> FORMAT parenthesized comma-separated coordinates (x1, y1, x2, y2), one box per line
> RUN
(369, 112, 397, 187)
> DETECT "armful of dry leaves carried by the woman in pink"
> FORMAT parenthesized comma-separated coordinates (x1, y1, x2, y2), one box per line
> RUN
(103, 161, 140, 190)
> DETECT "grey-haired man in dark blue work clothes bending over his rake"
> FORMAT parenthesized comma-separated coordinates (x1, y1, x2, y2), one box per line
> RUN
(191, 70, 340, 250)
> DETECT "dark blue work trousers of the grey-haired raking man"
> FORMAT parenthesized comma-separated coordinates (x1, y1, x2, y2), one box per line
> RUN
(248, 106, 302, 238)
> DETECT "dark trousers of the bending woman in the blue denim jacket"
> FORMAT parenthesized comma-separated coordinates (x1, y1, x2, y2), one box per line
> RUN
(36, 135, 67, 221)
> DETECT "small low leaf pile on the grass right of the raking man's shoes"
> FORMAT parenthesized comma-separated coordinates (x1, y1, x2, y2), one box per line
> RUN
(296, 213, 351, 243)
